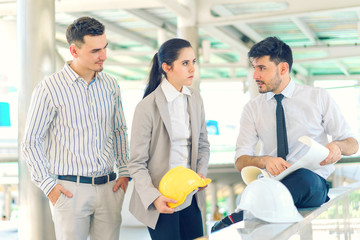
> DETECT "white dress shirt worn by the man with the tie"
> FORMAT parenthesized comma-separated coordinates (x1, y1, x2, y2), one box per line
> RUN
(235, 80, 354, 179)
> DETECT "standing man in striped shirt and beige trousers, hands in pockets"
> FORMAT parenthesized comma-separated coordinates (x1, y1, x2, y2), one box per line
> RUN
(22, 17, 129, 240)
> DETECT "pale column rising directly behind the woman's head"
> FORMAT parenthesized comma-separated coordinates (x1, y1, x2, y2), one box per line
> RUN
(177, 0, 200, 90)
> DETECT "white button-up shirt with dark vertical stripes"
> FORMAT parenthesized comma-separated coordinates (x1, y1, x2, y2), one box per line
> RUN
(22, 63, 129, 196)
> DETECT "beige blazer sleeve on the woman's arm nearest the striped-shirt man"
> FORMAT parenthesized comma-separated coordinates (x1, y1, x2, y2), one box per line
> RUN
(128, 101, 161, 209)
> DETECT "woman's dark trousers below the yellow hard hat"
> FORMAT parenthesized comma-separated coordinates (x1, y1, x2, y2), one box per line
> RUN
(148, 196, 204, 240)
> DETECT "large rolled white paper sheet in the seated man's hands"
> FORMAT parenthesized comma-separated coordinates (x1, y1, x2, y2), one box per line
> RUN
(241, 136, 329, 184)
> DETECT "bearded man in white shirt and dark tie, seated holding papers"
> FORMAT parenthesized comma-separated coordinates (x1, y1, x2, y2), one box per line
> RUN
(235, 37, 358, 208)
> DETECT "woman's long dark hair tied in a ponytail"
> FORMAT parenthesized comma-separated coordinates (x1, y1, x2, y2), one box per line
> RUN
(143, 38, 191, 98)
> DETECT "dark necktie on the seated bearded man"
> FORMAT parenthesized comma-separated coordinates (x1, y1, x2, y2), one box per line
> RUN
(274, 94, 289, 160)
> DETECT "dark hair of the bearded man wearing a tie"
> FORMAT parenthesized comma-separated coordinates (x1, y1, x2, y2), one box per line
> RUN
(248, 37, 293, 72)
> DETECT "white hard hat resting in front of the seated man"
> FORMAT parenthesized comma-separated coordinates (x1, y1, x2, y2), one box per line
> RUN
(238, 178, 303, 223)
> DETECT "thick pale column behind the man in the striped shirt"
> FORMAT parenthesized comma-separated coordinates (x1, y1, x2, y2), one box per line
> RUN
(17, 0, 55, 240)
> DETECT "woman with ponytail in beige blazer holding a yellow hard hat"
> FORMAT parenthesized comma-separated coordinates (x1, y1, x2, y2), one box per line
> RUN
(128, 38, 210, 240)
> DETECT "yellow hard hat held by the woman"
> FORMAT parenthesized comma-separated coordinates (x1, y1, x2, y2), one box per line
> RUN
(159, 166, 211, 208)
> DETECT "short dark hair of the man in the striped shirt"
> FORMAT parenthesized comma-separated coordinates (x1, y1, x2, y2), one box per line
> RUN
(66, 17, 105, 45)
